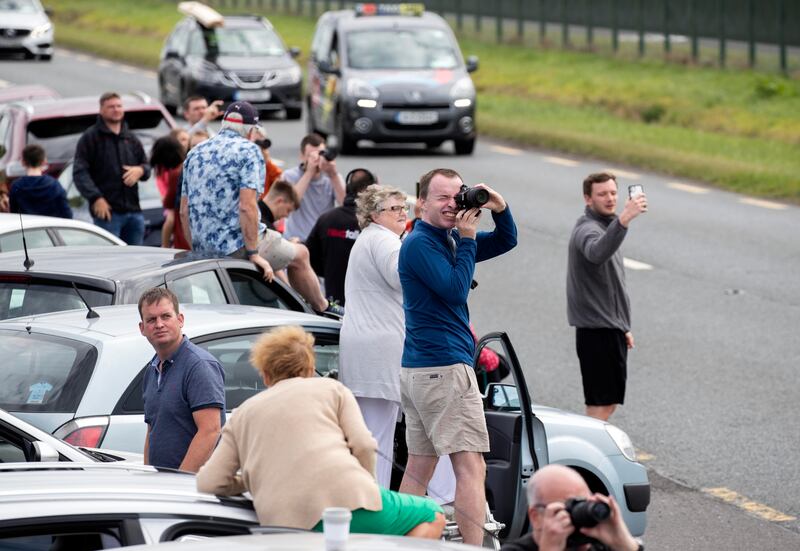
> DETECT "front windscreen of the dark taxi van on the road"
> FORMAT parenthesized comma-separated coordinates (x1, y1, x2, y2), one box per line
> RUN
(345, 28, 459, 70)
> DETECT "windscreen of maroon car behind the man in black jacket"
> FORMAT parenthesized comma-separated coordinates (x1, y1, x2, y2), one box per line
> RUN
(27, 110, 171, 163)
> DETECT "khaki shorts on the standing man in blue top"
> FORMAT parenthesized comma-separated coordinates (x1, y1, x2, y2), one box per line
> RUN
(400, 363, 489, 456)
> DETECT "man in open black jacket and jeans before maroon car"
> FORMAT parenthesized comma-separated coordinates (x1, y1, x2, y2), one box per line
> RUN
(72, 92, 150, 245)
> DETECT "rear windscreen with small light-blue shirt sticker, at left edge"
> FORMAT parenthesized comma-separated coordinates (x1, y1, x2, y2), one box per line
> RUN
(0, 329, 97, 413)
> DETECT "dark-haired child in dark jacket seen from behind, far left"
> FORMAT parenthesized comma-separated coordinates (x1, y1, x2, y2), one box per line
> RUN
(9, 145, 72, 218)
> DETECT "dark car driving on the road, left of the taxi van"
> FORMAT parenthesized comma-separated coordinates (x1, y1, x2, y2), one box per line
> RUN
(158, 16, 303, 119)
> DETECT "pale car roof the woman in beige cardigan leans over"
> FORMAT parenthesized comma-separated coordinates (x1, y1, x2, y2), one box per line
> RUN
(0, 462, 255, 526)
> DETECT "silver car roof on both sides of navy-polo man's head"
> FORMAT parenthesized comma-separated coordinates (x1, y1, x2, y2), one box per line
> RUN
(0, 304, 341, 341)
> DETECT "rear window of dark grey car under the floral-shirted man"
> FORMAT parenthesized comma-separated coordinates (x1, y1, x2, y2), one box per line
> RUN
(0, 275, 114, 319)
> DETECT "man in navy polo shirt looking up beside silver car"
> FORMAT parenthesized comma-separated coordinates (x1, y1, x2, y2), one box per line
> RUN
(139, 287, 225, 472)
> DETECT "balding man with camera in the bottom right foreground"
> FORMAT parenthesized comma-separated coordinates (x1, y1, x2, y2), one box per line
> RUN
(502, 465, 644, 551)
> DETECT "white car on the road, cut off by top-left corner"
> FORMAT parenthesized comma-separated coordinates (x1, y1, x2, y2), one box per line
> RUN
(0, 0, 53, 61)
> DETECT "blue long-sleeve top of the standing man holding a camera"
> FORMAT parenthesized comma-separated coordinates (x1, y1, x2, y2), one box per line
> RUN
(398, 207, 517, 367)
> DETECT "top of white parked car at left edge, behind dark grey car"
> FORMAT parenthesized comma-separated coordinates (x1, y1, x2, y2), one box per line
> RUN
(0, 212, 125, 253)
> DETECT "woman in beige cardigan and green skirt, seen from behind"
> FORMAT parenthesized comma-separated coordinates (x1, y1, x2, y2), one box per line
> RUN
(197, 327, 445, 538)
